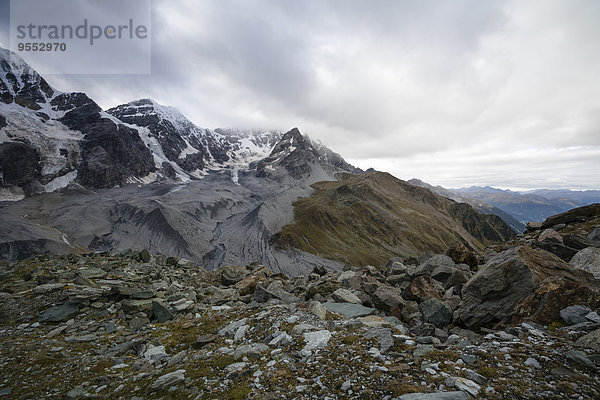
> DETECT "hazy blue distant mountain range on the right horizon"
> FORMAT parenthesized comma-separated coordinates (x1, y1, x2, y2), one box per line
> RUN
(409, 179, 600, 232)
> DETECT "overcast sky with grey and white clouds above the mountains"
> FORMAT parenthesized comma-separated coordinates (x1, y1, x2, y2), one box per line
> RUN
(0, 0, 600, 189)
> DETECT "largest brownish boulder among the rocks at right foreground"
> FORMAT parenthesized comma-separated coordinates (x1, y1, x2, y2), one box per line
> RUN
(457, 246, 599, 329)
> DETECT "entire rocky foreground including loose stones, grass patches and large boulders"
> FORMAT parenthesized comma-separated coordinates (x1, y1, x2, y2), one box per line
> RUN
(0, 205, 600, 399)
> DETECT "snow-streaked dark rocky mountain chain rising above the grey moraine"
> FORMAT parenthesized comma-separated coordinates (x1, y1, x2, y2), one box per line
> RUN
(0, 49, 358, 200)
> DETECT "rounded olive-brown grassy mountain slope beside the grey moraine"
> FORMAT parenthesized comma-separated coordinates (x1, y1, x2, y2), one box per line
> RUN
(272, 172, 515, 265)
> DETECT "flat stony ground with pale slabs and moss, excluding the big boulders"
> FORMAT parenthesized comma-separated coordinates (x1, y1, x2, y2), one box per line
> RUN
(0, 248, 600, 400)
